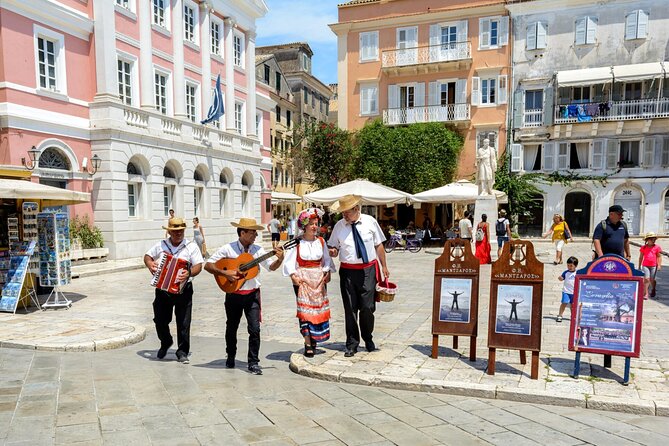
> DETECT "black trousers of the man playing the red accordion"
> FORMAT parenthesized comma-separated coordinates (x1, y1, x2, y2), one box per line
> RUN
(153, 282, 193, 355)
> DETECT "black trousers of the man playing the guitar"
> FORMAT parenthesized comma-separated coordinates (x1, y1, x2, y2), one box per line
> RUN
(225, 290, 260, 365)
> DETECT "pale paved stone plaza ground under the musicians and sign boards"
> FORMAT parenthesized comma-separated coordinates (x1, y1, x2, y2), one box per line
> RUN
(0, 243, 669, 446)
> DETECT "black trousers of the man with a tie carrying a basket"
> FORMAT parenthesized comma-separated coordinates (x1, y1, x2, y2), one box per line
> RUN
(339, 266, 376, 350)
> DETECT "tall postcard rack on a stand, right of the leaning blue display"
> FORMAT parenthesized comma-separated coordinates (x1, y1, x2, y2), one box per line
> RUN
(37, 212, 72, 310)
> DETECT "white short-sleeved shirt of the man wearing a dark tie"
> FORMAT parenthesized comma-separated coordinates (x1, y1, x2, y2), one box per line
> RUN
(328, 214, 386, 263)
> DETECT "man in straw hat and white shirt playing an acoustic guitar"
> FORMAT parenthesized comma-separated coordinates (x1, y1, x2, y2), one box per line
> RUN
(204, 218, 283, 375)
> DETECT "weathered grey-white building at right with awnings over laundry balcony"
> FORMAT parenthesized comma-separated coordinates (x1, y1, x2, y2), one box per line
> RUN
(508, 0, 669, 235)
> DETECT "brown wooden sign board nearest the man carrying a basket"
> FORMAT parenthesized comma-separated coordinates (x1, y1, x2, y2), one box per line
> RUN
(432, 239, 481, 361)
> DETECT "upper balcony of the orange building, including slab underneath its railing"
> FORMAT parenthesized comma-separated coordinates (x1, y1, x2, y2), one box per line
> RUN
(381, 42, 472, 74)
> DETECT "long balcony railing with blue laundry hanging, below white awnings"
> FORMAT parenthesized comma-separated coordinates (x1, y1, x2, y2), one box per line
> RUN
(555, 98, 669, 124)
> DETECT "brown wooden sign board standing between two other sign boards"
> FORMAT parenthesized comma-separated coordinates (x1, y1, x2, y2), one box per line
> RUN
(488, 240, 544, 379)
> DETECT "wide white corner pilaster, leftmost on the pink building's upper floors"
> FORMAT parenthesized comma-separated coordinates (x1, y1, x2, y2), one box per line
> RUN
(93, 2, 119, 102)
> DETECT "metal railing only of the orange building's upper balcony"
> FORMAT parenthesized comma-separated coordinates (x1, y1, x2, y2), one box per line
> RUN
(381, 42, 472, 68)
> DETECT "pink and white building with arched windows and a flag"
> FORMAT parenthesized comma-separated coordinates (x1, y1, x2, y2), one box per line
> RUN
(0, 0, 275, 258)
